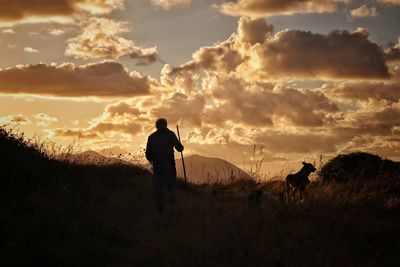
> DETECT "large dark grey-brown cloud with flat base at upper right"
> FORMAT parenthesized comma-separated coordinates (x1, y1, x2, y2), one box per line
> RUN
(259, 29, 389, 79)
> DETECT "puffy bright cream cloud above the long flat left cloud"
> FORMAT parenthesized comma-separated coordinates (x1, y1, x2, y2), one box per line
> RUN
(65, 17, 158, 64)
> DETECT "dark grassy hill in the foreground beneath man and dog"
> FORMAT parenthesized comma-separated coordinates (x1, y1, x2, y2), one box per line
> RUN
(0, 129, 400, 266)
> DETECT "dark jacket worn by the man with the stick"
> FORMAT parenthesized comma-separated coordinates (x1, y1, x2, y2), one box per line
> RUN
(146, 127, 183, 166)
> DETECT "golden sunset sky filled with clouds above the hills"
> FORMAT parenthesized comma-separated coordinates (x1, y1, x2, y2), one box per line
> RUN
(0, 0, 400, 174)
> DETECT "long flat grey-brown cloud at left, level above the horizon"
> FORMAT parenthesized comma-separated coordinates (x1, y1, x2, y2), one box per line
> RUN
(0, 62, 157, 97)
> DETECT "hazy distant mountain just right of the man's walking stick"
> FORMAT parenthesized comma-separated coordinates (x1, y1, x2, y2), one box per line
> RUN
(176, 155, 250, 184)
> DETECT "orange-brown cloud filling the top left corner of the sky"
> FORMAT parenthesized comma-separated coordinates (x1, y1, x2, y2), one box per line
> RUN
(0, 0, 124, 26)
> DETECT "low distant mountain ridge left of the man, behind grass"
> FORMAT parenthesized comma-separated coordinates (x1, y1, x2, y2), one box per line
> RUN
(60, 150, 125, 165)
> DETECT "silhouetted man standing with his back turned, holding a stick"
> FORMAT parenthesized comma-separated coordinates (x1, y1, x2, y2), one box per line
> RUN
(146, 118, 183, 212)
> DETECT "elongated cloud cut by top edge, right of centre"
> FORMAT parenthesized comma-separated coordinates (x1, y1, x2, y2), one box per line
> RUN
(219, 0, 342, 17)
